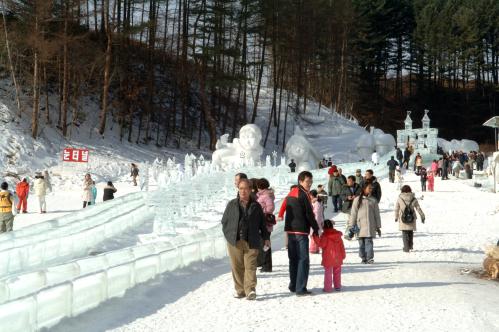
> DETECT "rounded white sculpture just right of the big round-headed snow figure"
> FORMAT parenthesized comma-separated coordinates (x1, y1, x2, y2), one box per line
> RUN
(285, 131, 321, 172)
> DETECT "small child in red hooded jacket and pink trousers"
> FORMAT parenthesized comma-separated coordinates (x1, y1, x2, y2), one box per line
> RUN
(314, 219, 346, 293)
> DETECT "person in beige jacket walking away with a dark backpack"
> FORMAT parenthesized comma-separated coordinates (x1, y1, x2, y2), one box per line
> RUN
(395, 185, 425, 252)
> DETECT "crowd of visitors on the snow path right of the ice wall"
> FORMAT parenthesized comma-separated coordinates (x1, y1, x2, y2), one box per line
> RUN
(222, 147, 492, 300)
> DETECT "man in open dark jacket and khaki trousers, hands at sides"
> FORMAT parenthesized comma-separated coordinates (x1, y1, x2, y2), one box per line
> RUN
(222, 179, 270, 300)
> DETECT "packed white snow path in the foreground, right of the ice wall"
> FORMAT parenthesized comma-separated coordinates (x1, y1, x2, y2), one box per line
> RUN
(54, 175, 499, 331)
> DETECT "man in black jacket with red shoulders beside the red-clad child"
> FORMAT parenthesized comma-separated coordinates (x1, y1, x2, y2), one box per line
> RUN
(284, 171, 319, 296)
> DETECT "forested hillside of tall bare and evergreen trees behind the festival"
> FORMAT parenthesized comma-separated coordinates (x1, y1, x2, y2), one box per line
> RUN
(0, 0, 499, 149)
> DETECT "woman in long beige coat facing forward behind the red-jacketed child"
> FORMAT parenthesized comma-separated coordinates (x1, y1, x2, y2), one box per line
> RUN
(348, 181, 381, 264)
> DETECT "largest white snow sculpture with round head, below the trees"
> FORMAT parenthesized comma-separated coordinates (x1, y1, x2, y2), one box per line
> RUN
(212, 124, 263, 168)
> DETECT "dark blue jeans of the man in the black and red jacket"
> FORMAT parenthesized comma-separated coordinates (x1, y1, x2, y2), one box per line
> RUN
(288, 234, 310, 294)
